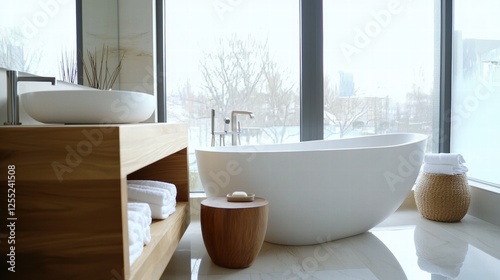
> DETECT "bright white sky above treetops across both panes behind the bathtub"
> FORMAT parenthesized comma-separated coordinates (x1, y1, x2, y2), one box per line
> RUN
(167, 0, 435, 100)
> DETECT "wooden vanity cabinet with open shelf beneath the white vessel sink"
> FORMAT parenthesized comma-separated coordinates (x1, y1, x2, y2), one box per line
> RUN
(0, 123, 190, 280)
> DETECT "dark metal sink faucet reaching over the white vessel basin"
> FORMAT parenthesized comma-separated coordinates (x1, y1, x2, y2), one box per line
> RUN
(4, 70, 57, 125)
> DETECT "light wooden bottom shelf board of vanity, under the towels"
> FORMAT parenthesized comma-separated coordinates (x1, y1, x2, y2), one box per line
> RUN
(127, 202, 190, 279)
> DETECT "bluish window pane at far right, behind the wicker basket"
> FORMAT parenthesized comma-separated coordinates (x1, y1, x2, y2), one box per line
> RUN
(451, 0, 500, 186)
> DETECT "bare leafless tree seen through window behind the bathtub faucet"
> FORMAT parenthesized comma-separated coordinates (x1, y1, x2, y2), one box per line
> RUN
(169, 36, 299, 147)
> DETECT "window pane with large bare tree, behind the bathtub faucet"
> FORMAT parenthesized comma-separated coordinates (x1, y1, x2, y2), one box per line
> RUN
(165, 0, 300, 191)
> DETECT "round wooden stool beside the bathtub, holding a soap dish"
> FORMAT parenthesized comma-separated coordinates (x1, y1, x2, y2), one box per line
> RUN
(200, 197, 269, 268)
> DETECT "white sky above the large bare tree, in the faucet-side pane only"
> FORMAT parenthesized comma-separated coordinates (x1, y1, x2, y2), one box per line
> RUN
(167, 0, 299, 94)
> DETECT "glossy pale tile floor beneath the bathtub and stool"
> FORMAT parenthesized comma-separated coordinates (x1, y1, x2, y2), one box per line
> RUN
(161, 202, 500, 280)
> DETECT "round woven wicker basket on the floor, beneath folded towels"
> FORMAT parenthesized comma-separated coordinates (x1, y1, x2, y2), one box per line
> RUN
(415, 172, 470, 222)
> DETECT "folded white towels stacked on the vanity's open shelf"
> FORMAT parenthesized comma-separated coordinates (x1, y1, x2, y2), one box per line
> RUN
(127, 180, 177, 264)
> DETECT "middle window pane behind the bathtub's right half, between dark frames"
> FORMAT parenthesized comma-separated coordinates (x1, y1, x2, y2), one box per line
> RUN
(323, 0, 440, 151)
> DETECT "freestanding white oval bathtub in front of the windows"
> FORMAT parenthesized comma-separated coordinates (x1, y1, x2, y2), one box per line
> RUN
(196, 134, 427, 245)
